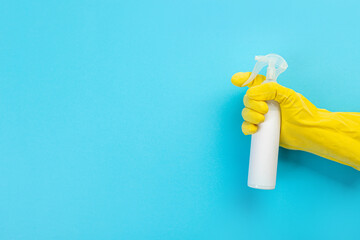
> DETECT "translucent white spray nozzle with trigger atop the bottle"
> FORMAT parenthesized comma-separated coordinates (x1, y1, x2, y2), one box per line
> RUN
(242, 54, 288, 86)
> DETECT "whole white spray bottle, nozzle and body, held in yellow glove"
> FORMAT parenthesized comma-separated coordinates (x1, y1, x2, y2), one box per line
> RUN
(243, 54, 288, 189)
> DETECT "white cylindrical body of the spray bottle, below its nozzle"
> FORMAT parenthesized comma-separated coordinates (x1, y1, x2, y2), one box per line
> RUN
(248, 101, 281, 189)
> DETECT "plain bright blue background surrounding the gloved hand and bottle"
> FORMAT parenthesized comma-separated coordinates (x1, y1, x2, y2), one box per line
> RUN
(0, 0, 360, 239)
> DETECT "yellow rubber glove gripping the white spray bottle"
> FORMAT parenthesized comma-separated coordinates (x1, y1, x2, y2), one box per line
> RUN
(231, 72, 360, 170)
